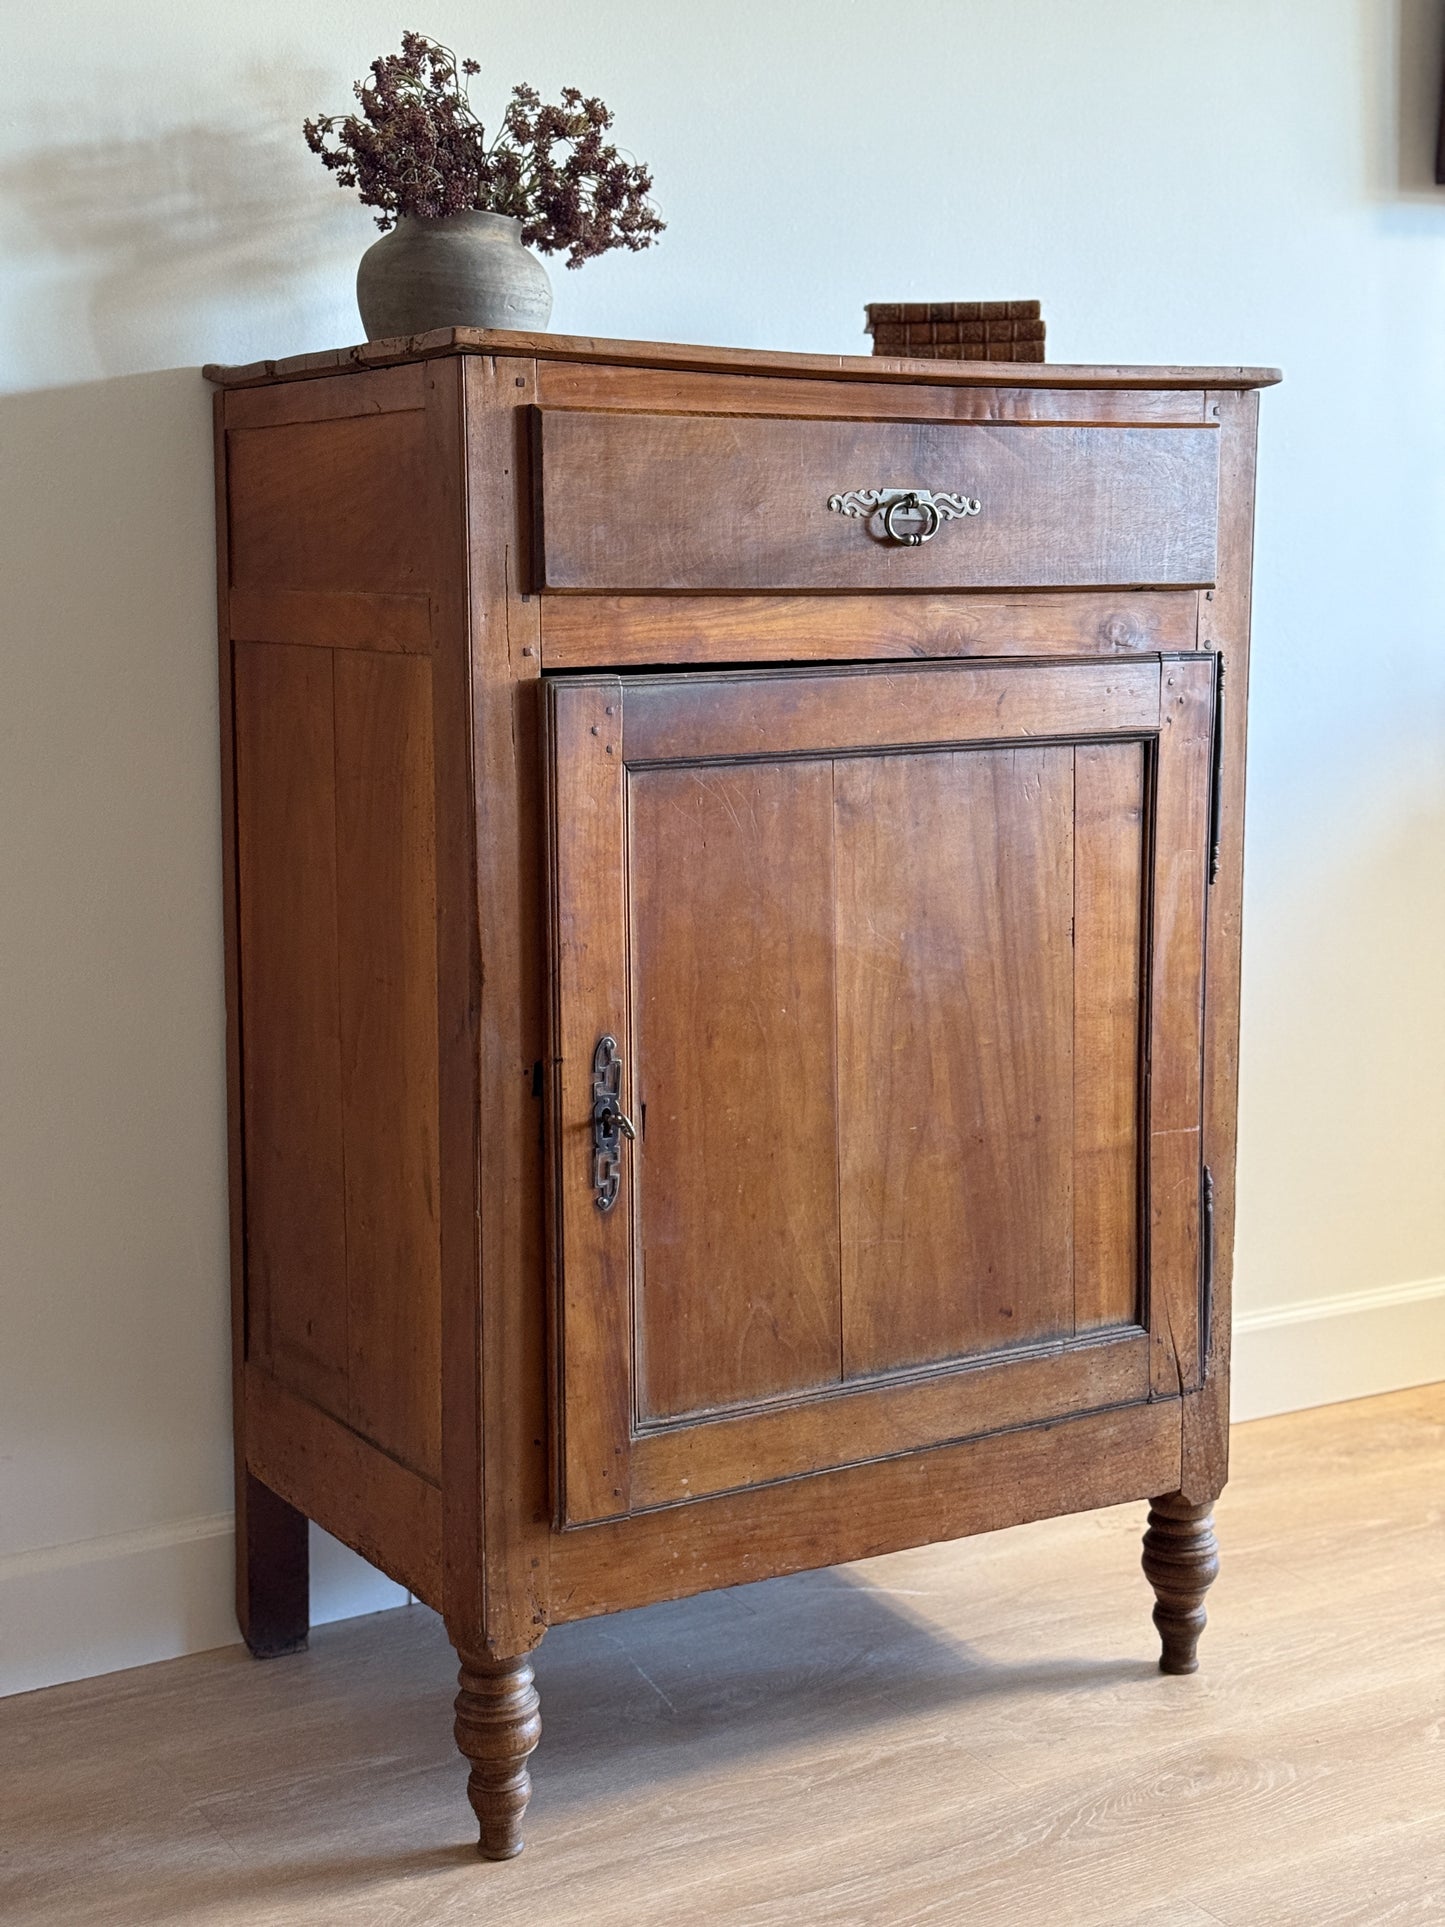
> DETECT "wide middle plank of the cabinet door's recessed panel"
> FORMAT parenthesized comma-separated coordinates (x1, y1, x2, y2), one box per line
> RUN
(836, 746, 1073, 1378)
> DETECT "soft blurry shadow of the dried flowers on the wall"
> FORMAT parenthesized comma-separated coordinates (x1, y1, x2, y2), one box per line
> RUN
(0, 98, 362, 374)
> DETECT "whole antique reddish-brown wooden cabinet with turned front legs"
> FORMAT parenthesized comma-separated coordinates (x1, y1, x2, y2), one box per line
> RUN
(208, 330, 1275, 1858)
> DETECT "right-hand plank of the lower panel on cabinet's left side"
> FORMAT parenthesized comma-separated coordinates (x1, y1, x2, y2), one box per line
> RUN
(335, 651, 441, 1478)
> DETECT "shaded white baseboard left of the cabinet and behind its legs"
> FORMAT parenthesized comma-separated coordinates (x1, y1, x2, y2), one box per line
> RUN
(0, 1513, 407, 1696)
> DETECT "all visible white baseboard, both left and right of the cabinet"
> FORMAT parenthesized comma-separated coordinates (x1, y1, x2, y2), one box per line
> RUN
(0, 1278, 1445, 1696)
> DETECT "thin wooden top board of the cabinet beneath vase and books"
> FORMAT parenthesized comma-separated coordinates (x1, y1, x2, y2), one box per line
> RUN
(202, 328, 1279, 389)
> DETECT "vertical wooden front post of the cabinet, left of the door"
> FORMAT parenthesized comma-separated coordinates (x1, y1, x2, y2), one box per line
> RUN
(460, 358, 551, 1657)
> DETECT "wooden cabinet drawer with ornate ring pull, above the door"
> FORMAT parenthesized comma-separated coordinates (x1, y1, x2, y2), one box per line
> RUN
(538, 409, 1220, 594)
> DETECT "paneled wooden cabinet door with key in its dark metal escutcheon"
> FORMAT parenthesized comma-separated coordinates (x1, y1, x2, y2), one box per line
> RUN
(547, 655, 1214, 1524)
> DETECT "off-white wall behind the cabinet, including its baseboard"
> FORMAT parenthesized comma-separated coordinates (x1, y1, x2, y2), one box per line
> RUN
(0, 0, 1445, 1688)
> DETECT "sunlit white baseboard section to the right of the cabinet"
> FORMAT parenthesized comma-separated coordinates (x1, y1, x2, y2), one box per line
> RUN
(1229, 1278, 1445, 1424)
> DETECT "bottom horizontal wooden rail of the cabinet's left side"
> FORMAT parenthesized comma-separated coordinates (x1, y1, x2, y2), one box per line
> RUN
(245, 1366, 441, 1605)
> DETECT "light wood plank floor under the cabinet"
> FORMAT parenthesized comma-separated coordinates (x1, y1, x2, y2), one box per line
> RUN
(0, 1386, 1445, 1927)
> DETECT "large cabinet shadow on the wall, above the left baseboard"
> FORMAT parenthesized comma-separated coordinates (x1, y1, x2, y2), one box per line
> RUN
(0, 368, 229, 1547)
